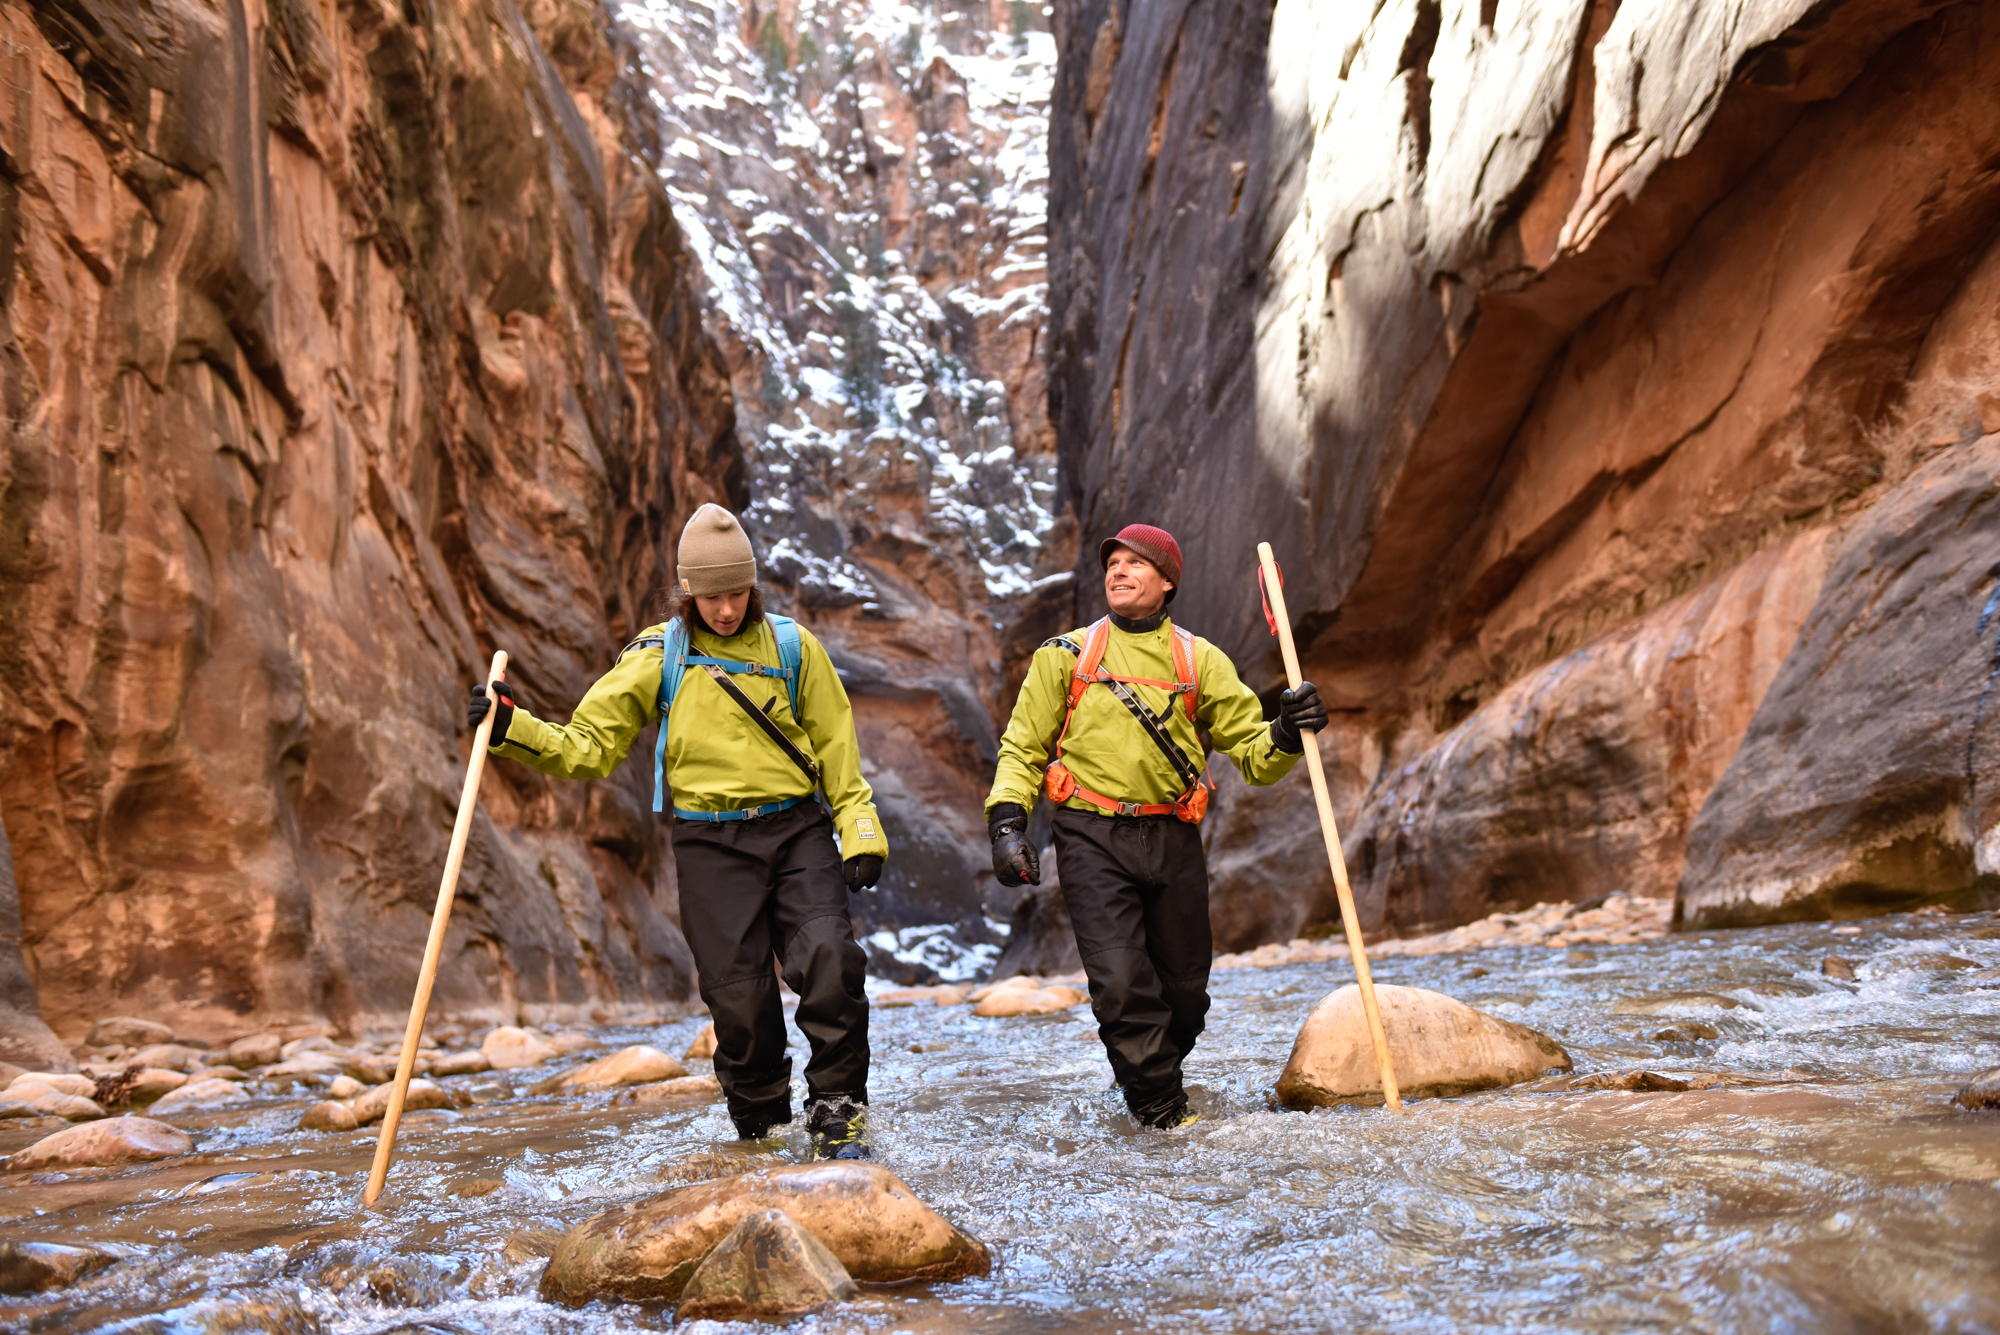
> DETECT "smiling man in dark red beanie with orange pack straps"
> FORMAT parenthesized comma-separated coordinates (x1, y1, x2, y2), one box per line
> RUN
(986, 524, 1326, 1127)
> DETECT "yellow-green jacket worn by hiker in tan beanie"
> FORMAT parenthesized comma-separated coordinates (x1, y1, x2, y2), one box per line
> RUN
(492, 620, 888, 857)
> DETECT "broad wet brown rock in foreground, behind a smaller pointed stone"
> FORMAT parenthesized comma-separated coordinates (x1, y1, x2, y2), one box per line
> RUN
(542, 1163, 992, 1303)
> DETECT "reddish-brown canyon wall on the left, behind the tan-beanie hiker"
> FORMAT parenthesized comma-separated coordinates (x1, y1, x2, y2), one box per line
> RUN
(0, 0, 748, 1041)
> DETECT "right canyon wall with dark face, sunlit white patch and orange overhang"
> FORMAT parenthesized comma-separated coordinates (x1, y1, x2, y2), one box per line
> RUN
(1048, 0, 2000, 947)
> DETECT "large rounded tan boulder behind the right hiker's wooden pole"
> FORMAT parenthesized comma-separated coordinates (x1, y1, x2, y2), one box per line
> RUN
(1278, 983, 1570, 1107)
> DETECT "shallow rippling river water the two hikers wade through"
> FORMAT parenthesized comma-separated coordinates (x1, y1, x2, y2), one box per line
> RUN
(0, 913, 2000, 1335)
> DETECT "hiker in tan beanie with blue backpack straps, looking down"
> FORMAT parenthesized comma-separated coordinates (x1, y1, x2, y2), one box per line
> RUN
(466, 506, 888, 1159)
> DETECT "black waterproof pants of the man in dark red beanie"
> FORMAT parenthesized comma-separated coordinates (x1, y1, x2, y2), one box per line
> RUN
(1054, 807, 1214, 1119)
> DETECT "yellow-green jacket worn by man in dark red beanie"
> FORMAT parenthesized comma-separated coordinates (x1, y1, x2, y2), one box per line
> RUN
(986, 618, 1300, 811)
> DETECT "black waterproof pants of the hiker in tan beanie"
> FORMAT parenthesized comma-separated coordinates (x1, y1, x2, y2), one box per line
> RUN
(674, 801, 868, 1123)
